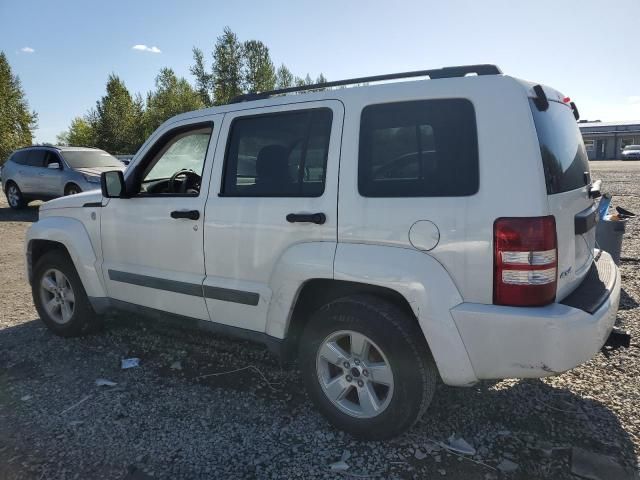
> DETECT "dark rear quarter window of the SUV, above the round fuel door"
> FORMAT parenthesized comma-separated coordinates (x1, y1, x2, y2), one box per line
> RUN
(358, 98, 479, 197)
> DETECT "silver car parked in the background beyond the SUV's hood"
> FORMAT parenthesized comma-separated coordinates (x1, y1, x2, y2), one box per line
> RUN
(2, 147, 125, 208)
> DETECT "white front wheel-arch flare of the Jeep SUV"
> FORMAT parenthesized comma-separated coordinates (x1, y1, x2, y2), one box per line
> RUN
(25, 216, 106, 297)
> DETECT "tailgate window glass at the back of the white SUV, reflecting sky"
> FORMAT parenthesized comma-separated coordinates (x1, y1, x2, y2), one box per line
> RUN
(529, 100, 589, 194)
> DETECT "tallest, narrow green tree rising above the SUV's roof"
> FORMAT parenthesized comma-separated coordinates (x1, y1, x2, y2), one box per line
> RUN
(212, 27, 244, 105)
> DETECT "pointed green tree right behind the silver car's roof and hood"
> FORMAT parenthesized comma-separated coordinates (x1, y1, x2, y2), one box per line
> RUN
(93, 74, 144, 154)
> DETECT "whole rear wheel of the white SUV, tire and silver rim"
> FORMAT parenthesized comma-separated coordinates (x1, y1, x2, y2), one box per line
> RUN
(299, 295, 437, 440)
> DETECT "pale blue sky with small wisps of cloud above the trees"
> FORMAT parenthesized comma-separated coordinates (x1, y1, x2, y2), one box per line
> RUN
(0, 0, 640, 143)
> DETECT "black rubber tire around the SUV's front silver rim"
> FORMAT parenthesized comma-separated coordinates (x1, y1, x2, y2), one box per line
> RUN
(31, 250, 102, 337)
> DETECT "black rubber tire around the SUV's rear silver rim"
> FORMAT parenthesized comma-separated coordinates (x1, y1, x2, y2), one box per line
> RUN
(299, 295, 438, 440)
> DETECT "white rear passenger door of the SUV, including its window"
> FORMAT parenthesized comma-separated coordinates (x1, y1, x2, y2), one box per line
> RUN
(204, 101, 344, 332)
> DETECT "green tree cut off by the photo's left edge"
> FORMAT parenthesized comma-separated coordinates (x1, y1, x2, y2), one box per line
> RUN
(0, 51, 38, 165)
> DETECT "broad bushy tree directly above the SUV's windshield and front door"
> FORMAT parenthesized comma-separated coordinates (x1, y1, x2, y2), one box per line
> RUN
(144, 68, 205, 136)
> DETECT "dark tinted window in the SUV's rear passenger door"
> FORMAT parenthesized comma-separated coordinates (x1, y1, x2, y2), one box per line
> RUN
(221, 108, 333, 197)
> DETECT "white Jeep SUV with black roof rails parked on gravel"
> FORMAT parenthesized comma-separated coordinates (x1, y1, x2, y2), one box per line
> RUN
(26, 65, 620, 439)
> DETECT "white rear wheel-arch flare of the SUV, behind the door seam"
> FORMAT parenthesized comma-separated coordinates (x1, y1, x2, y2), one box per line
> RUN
(334, 243, 478, 386)
